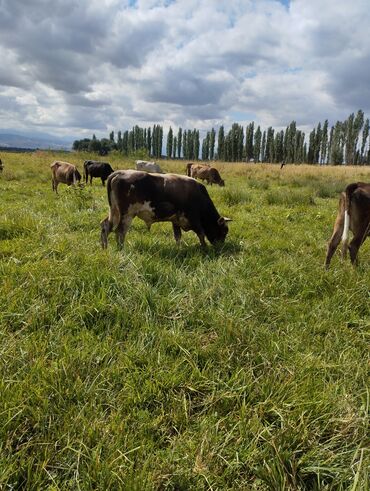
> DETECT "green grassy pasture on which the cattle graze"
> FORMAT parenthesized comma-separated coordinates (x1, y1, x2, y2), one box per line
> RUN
(0, 152, 370, 491)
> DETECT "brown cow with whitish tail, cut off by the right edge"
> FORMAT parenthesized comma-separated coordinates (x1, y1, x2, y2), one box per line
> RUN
(325, 182, 370, 268)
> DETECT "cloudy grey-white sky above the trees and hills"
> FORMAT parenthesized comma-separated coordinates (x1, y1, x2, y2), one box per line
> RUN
(0, 0, 370, 138)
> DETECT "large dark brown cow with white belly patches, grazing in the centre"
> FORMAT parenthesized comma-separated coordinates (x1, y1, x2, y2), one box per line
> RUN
(100, 170, 230, 249)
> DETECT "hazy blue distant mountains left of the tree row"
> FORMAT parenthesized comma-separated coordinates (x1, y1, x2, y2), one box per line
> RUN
(0, 130, 72, 150)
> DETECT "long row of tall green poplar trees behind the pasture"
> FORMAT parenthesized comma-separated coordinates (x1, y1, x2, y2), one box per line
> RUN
(73, 109, 370, 165)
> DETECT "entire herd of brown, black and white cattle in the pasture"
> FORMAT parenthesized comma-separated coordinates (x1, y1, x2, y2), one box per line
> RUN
(0, 159, 370, 268)
